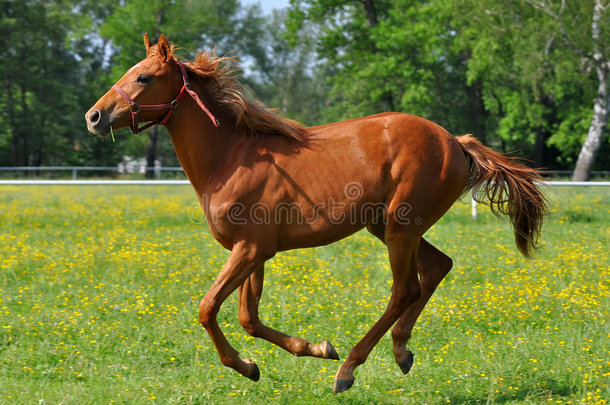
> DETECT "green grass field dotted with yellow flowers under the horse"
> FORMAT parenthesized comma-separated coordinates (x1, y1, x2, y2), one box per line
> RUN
(0, 186, 610, 404)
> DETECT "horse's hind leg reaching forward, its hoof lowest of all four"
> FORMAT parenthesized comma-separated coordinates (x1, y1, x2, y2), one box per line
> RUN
(333, 230, 420, 392)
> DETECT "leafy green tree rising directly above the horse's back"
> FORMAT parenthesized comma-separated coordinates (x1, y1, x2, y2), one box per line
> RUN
(290, 0, 482, 132)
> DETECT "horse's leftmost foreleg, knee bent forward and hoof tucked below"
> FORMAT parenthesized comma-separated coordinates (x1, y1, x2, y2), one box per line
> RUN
(199, 243, 269, 381)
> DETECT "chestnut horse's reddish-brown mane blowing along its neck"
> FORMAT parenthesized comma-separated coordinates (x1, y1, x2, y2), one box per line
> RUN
(172, 48, 307, 141)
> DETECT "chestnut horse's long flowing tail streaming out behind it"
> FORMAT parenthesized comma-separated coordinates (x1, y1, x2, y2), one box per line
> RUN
(456, 135, 547, 258)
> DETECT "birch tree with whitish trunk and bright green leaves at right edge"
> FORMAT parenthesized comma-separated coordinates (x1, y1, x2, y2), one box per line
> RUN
(457, 0, 610, 176)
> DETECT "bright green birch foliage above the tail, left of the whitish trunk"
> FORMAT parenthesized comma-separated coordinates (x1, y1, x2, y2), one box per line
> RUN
(456, 0, 604, 168)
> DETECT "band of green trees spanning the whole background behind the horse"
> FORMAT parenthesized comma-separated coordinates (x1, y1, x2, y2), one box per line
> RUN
(0, 0, 610, 180)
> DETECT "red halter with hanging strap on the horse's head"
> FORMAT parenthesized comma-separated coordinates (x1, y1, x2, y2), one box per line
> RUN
(112, 61, 219, 134)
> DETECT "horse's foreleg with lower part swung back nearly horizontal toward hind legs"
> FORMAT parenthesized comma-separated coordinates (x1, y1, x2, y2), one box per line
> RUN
(239, 264, 339, 360)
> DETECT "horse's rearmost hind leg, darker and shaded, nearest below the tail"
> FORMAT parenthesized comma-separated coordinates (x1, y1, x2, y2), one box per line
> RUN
(392, 238, 453, 374)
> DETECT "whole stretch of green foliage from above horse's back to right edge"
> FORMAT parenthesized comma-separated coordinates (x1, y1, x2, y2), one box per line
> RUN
(290, 0, 610, 168)
